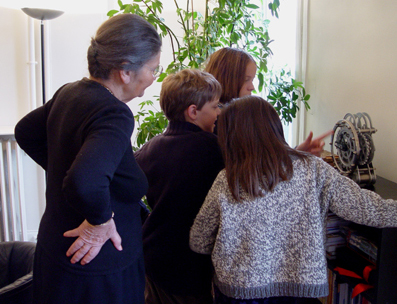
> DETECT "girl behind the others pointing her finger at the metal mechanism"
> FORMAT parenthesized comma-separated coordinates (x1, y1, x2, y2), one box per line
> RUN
(205, 47, 332, 156)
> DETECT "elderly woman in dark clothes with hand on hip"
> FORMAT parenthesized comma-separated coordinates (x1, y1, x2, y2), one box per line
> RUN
(15, 14, 161, 304)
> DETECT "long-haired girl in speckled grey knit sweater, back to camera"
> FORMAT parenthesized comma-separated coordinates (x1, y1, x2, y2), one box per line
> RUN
(190, 96, 397, 304)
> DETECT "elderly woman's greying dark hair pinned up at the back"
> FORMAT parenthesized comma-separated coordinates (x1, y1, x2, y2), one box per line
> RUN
(87, 14, 161, 79)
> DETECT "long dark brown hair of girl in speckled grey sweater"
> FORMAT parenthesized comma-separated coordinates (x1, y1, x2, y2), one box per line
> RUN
(218, 96, 307, 201)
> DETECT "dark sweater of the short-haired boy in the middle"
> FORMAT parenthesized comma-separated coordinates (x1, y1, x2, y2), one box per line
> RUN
(135, 121, 224, 295)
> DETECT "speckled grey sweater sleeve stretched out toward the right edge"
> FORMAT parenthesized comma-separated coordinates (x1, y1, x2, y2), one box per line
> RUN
(321, 159, 397, 228)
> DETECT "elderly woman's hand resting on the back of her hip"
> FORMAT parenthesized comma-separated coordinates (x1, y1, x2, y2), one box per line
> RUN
(63, 218, 123, 265)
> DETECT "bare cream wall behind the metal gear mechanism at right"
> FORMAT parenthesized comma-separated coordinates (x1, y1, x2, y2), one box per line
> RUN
(306, 0, 397, 182)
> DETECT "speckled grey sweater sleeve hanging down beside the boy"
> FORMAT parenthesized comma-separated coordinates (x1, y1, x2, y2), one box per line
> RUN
(189, 171, 226, 254)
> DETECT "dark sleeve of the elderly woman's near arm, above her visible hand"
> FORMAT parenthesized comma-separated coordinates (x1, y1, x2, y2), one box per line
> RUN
(62, 106, 134, 225)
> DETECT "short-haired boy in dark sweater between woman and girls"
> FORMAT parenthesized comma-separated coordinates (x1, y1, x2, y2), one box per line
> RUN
(135, 70, 224, 304)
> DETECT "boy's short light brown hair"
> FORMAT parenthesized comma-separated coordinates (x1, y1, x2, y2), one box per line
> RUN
(160, 69, 222, 121)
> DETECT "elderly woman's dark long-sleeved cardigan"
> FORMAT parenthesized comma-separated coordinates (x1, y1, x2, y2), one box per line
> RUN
(15, 78, 147, 274)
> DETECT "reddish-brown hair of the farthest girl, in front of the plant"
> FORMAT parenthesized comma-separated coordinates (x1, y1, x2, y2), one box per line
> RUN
(205, 47, 256, 104)
